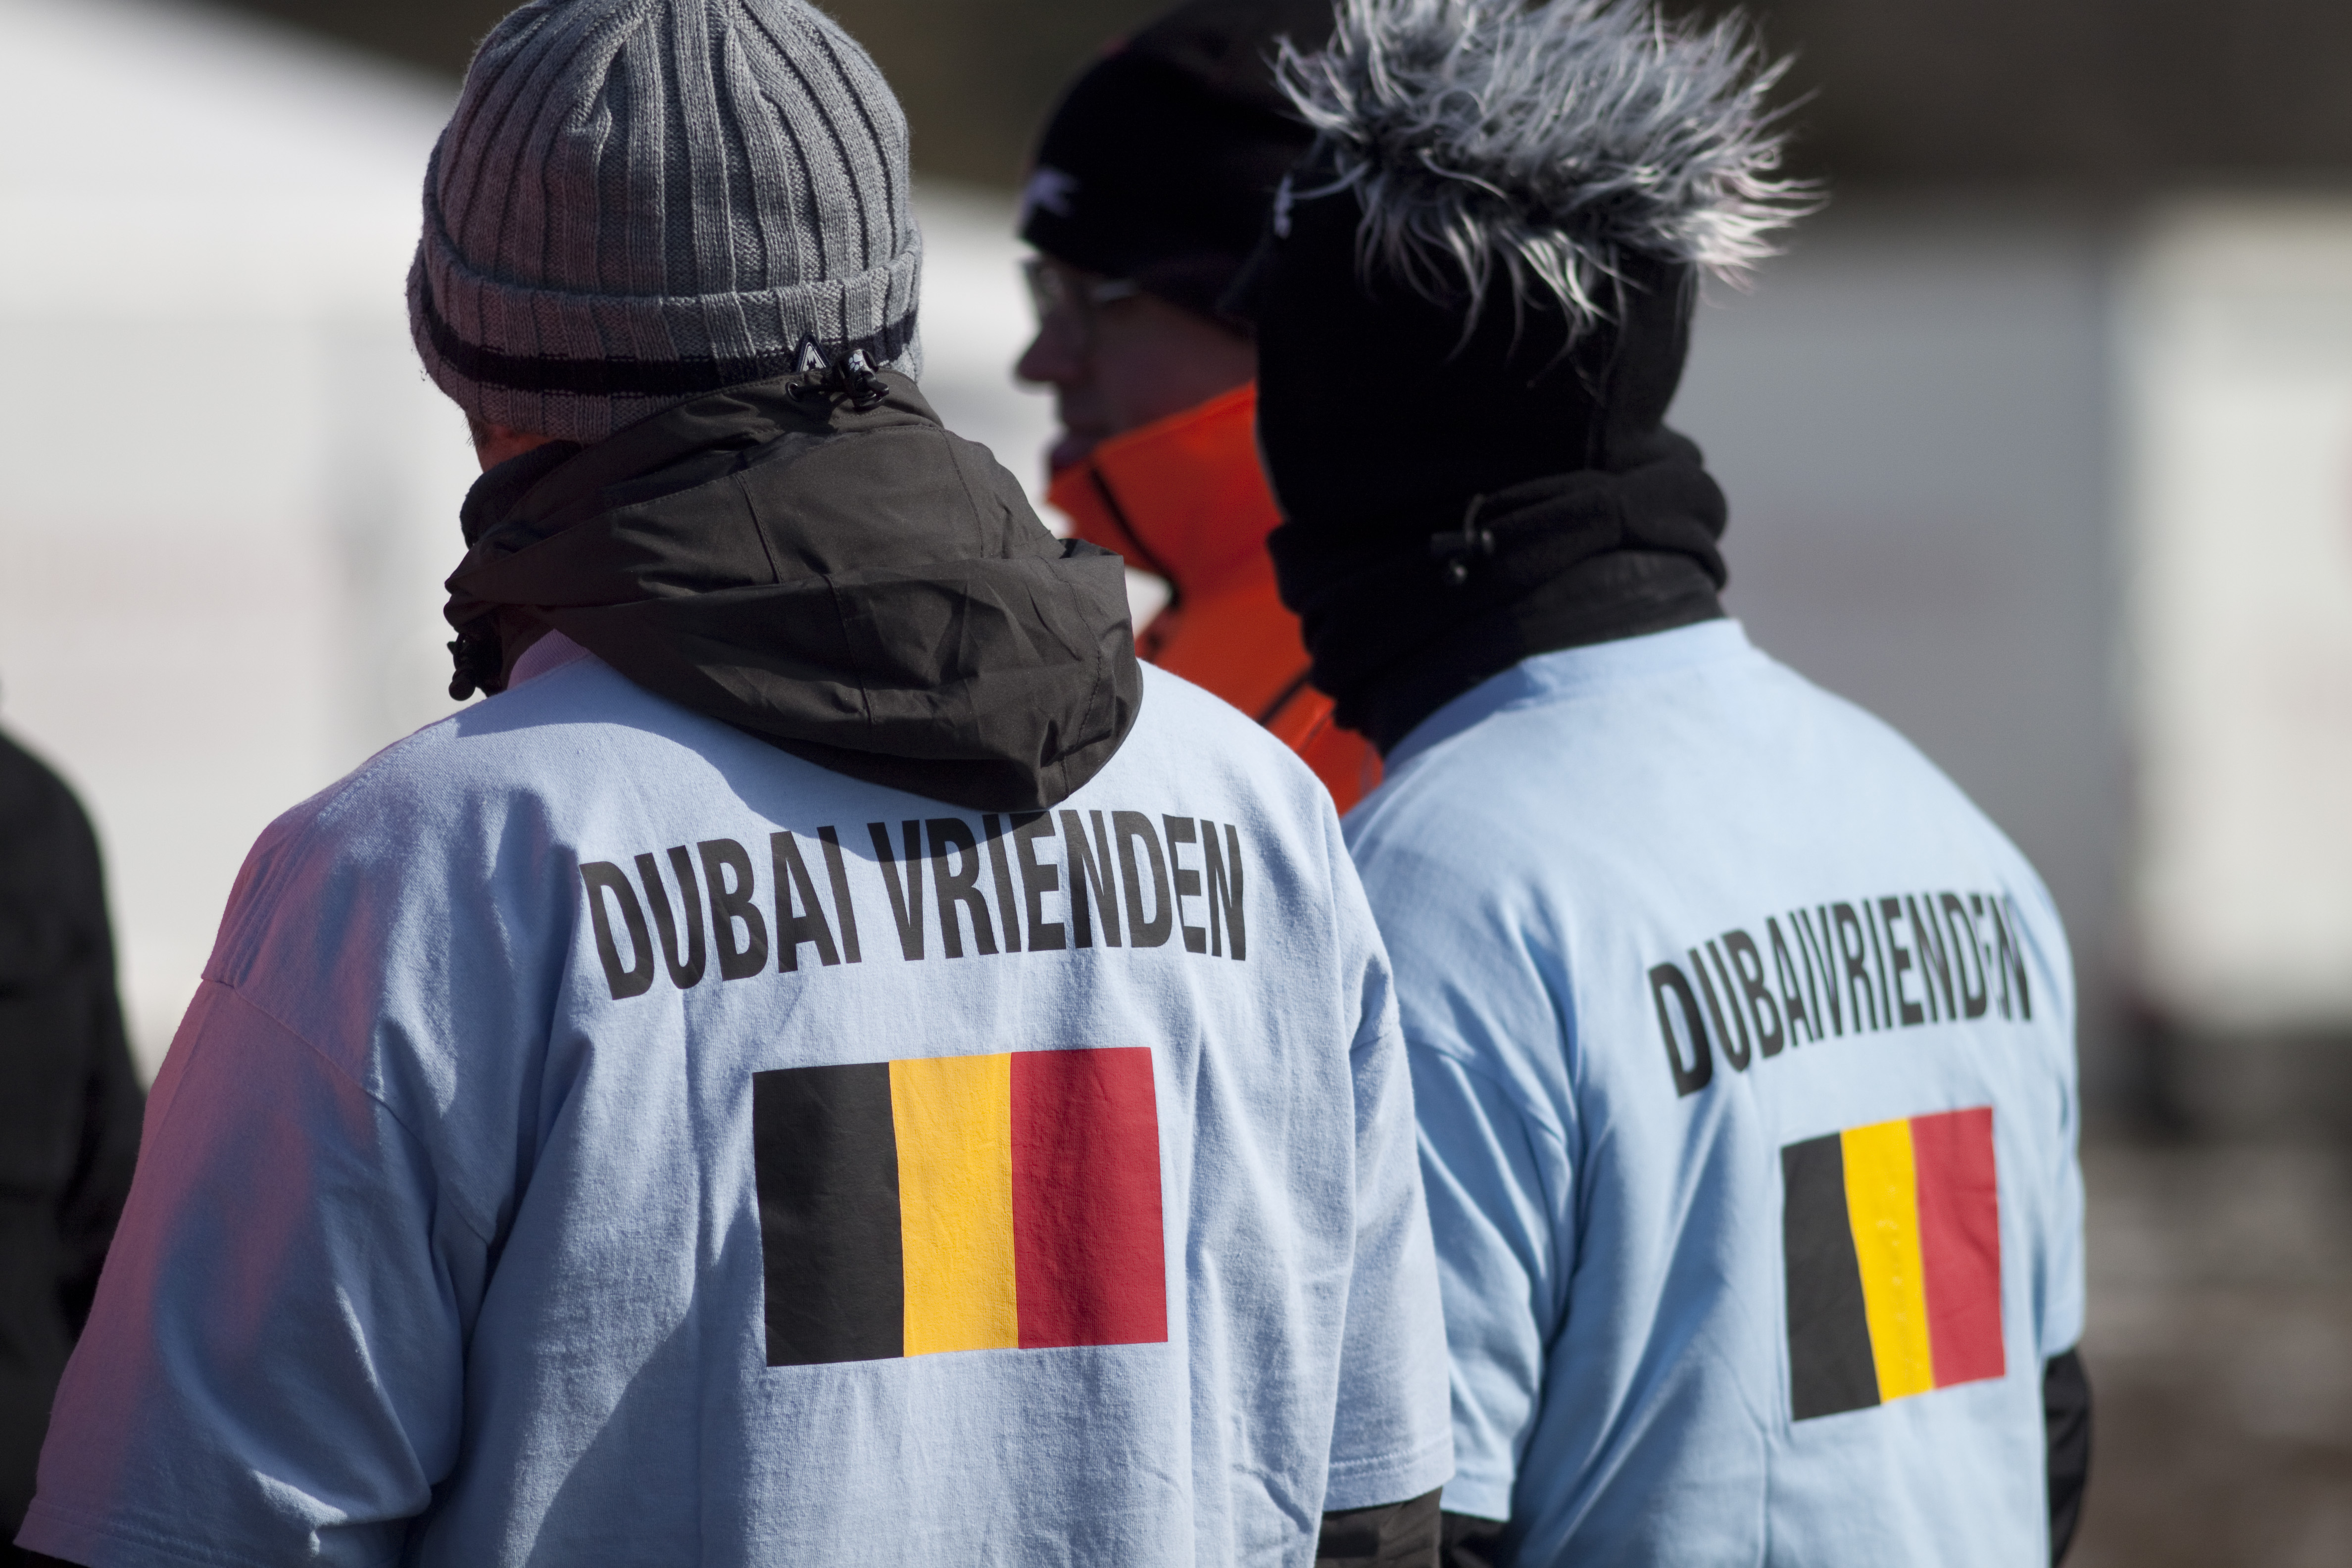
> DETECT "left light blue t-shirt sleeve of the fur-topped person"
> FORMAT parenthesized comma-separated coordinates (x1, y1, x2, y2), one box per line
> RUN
(1411, 1044, 1576, 1519)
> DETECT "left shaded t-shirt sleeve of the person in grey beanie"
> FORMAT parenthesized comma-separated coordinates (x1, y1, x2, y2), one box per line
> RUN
(19, 980, 487, 1568)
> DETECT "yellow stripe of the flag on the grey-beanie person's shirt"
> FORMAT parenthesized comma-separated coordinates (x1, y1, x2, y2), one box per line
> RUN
(889, 1056, 1021, 1357)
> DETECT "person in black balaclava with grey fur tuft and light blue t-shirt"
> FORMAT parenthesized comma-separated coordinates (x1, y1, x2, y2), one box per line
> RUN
(1237, 0, 2089, 1568)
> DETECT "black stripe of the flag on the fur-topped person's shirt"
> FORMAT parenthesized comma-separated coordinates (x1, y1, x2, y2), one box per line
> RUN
(1780, 1133, 1879, 1420)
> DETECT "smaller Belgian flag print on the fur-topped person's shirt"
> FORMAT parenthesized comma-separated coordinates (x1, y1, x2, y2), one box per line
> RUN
(1780, 1105, 2006, 1420)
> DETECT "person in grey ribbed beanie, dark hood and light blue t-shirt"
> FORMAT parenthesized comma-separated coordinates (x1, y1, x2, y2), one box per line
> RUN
(19, 0, 1451, 1568)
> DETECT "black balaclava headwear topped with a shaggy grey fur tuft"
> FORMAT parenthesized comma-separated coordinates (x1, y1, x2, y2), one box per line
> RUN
(1230, 0, 1811, 752)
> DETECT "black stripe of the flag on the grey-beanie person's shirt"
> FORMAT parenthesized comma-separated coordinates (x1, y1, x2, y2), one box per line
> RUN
(750, 1063, 906, 1366)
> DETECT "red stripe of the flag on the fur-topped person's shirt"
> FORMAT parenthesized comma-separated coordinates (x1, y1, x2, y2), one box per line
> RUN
(1912, 1105, 2006, 1389)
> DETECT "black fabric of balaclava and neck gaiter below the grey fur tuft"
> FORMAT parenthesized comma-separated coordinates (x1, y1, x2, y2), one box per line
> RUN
(1251, 193, 1726, 752)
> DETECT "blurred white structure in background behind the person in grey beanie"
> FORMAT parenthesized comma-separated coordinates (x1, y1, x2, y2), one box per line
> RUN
(0, 0, 1051, 1072)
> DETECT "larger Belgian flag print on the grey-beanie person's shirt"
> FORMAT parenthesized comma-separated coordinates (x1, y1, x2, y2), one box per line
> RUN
(753, 1046, 1169, 1366)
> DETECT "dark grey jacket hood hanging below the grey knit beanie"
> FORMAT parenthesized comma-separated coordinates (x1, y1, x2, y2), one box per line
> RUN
(444, 374, 1143, 811)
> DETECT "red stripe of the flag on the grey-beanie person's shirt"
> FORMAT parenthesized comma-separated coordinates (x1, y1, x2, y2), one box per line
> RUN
(1011, 1046, 1169, 1349)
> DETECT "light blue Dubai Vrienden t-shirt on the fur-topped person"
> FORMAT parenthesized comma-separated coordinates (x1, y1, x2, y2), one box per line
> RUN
(1348, 621, 2084, 1568)
